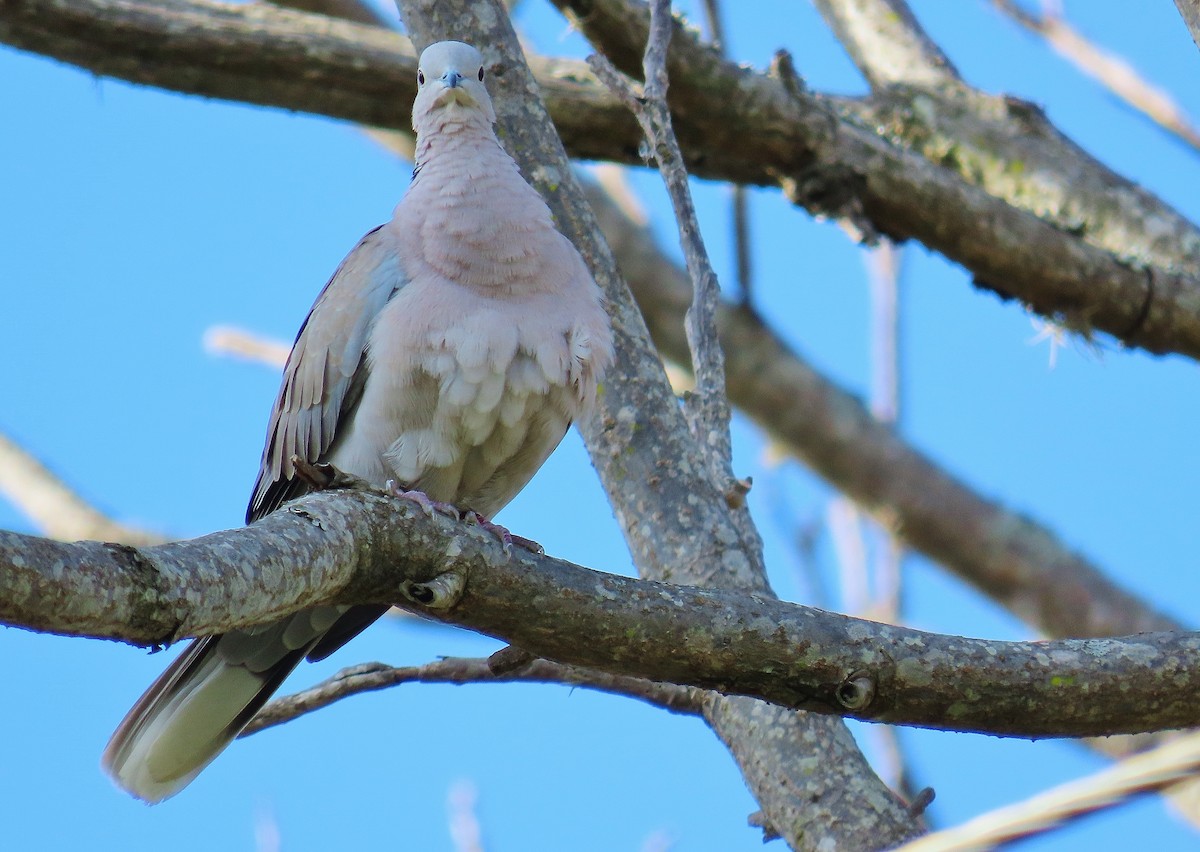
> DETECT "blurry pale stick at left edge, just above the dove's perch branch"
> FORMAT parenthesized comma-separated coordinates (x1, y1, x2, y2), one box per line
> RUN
(0, 434, 168, 545)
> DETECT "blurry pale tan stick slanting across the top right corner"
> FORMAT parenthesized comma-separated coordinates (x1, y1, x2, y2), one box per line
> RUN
(991, 0, 1200, 150)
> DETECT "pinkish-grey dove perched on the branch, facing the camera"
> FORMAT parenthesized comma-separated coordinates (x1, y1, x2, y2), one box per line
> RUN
(103, 42, 612, 803)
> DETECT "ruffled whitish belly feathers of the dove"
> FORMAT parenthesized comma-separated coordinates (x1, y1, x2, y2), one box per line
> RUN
(330, 284, 594, 516)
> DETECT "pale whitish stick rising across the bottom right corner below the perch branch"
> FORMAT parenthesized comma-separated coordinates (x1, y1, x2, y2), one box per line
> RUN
(894, 733, 1200, 852)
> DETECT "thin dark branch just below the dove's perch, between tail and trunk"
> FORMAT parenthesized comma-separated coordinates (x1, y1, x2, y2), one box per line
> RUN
(241, 656, 700, 737)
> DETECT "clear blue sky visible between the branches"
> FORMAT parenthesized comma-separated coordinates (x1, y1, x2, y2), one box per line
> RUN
(0, 0, 1200, 852)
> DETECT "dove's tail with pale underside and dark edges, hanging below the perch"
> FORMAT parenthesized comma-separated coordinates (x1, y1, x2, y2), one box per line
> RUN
(102, 634, 308, 804)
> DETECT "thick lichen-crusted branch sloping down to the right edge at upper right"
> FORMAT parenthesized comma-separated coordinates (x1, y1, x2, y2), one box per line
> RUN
(556, 0, 1200, 356)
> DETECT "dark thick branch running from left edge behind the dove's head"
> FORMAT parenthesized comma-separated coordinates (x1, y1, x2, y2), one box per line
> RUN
(0, 0, 638, 157)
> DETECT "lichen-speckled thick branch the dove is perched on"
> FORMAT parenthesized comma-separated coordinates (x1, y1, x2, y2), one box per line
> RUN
(0, 492, 1200, 737)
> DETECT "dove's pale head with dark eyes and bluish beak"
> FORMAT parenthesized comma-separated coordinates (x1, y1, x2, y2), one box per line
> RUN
(413, 42, 496, 133)
